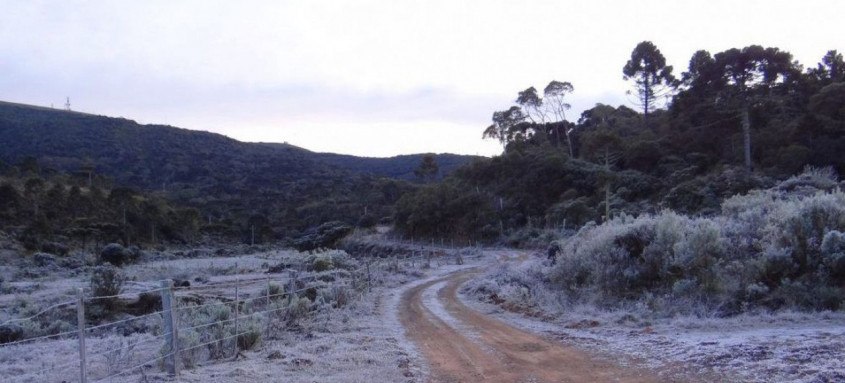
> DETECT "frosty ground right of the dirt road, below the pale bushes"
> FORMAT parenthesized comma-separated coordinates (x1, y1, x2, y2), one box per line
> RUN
(459, 256, 845, 383)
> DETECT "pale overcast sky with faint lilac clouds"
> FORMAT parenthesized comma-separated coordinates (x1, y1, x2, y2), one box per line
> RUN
(0, 0, 845, 157)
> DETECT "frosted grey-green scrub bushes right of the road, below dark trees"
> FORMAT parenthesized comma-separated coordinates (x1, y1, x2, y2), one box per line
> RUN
(471, 169, 845, 316)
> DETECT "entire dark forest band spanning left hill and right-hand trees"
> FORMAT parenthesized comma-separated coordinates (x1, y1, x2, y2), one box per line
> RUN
(0, 41, 845, 254)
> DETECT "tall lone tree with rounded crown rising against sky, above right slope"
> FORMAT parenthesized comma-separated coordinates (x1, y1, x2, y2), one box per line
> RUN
(622, 41, 675, 128)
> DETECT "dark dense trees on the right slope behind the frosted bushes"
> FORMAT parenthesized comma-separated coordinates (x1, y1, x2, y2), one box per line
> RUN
(396, 42, 845, 239)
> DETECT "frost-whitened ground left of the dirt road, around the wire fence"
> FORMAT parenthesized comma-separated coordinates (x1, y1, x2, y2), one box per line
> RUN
(0, 246, 484, 383)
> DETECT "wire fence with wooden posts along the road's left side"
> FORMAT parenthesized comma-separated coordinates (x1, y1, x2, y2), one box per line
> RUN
(0, 247, 481, 383)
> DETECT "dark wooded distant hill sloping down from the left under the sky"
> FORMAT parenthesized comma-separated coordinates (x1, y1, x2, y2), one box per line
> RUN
(0, 102, 473, 235)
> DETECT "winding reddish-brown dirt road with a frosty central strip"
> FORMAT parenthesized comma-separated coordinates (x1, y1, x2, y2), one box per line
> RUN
(399, 270, 660, 383)
